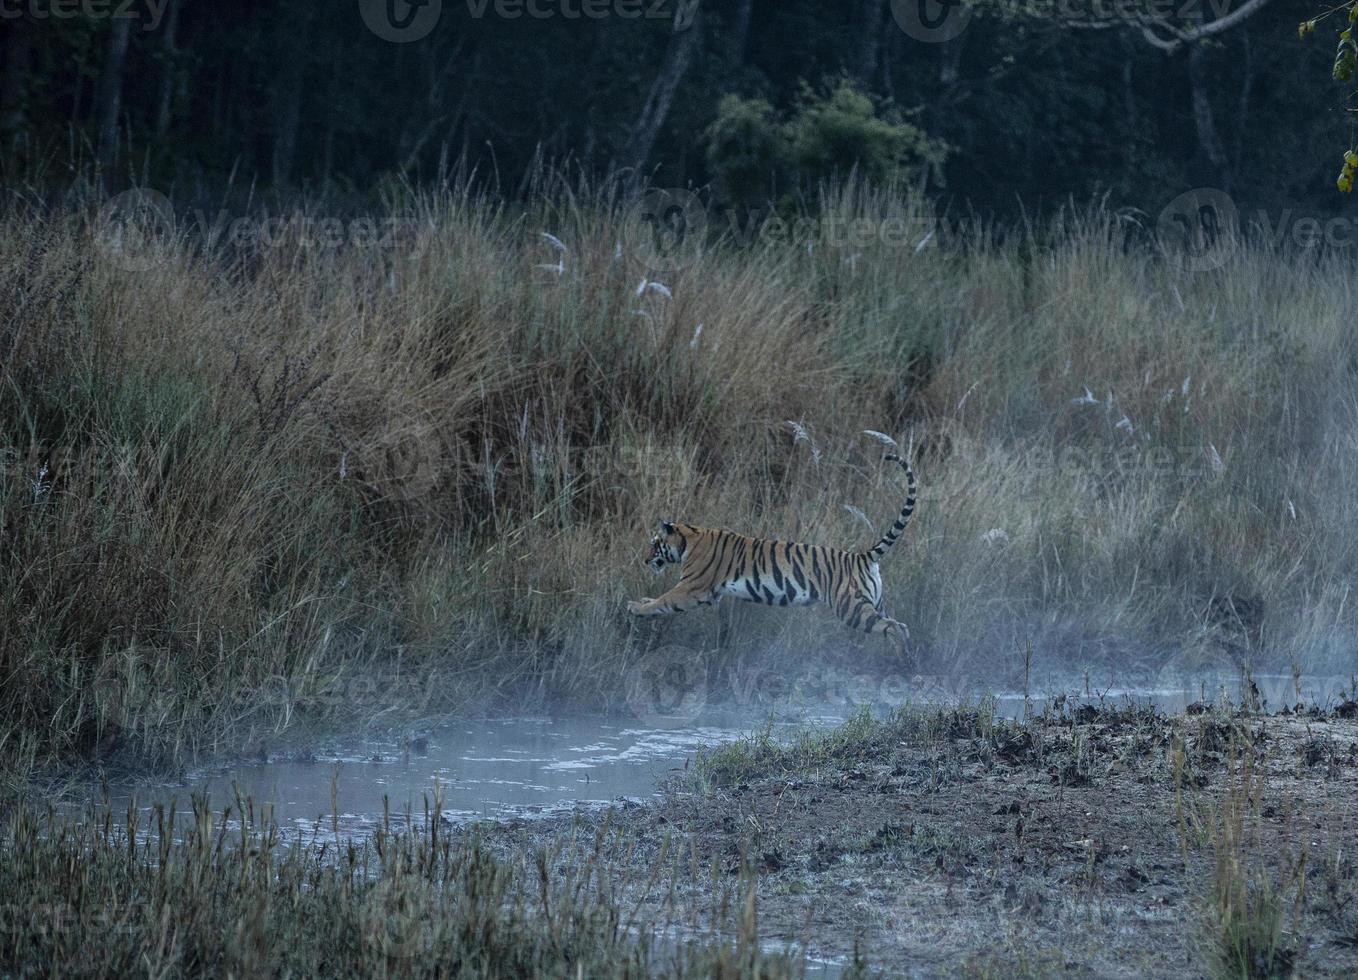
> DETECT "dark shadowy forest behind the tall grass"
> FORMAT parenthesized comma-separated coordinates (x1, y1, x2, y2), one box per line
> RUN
(0, 0, 1351, 214)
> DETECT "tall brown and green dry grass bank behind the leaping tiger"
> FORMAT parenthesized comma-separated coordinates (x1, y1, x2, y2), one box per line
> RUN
(0, 176, 1358, 764)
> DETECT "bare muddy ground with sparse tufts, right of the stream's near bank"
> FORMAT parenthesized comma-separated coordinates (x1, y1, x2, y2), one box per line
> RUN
(464, 704, 1358, 977)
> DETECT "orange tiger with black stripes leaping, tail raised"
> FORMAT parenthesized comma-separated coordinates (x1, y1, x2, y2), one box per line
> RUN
(627, 453, 918, 652)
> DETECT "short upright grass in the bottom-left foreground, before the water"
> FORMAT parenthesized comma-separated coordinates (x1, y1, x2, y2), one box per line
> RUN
(0, 797, 803, 980)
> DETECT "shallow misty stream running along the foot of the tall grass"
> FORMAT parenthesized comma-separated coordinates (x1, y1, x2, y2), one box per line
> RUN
(69, 672, 1355, 842)
